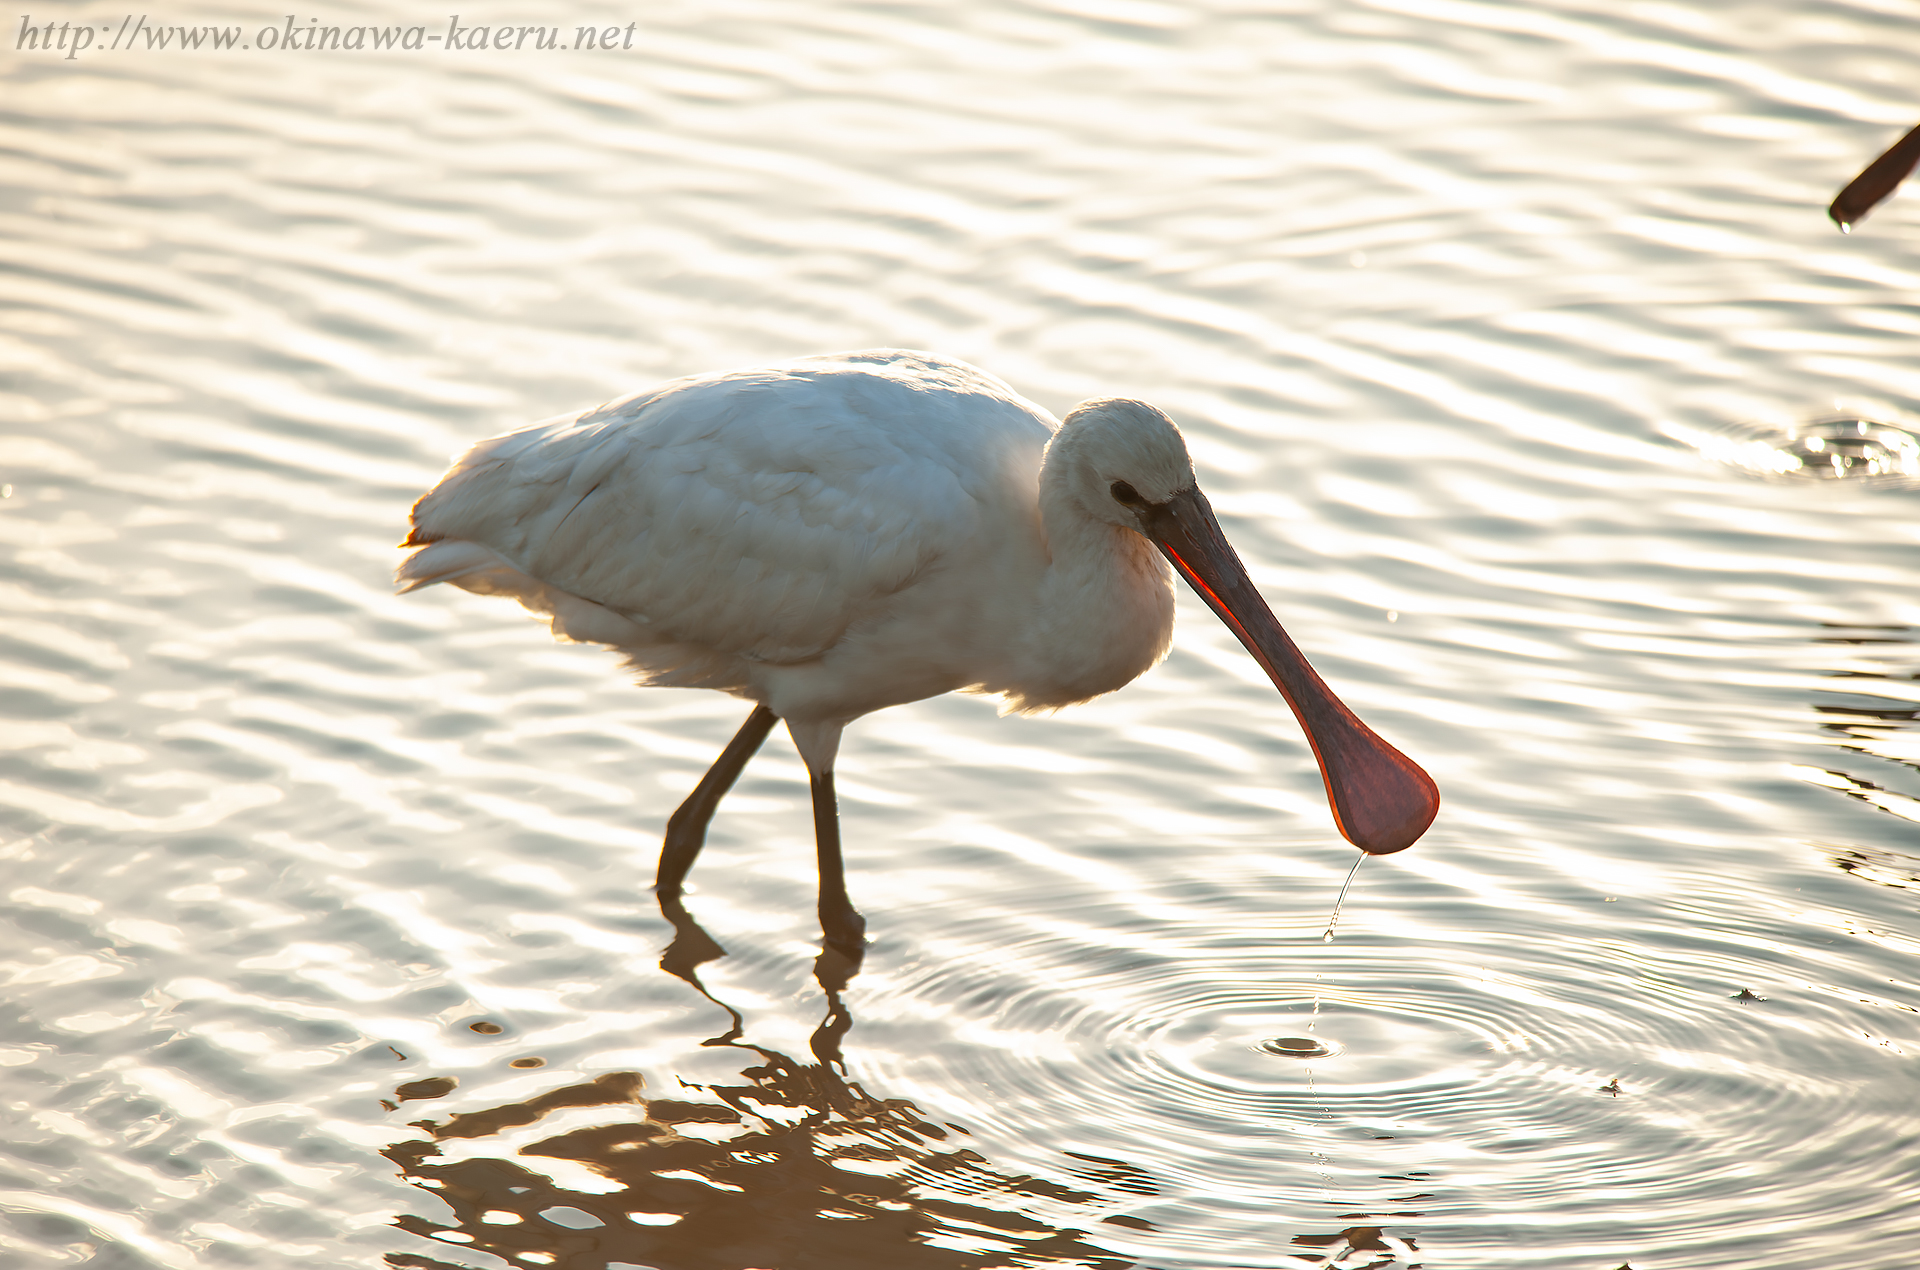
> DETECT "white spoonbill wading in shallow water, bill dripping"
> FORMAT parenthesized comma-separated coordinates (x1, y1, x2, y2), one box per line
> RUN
(397, 350, 1440, 947)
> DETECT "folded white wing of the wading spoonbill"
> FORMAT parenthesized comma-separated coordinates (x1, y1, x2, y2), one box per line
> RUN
(409, 351, 1046, 663)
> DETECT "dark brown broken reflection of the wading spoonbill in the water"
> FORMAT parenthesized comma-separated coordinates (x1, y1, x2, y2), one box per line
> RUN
(384, 895, 1419, 1270)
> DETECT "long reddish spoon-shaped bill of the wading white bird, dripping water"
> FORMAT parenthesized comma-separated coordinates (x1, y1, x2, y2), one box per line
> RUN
(1140, 486, 1440, 855)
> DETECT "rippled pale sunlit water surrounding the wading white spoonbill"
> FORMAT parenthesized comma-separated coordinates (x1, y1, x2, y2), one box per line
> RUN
(0, 0, 1920, 1270)
